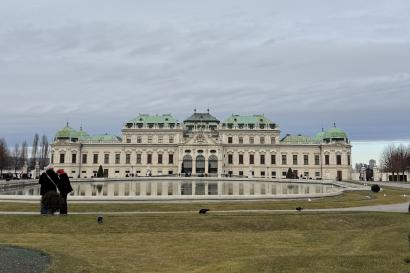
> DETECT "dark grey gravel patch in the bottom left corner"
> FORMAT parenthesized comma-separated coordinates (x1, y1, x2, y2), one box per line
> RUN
(0, 245, 50, 273)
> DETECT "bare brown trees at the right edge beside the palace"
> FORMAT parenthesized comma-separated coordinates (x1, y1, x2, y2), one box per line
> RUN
(380, 144, 410, 181)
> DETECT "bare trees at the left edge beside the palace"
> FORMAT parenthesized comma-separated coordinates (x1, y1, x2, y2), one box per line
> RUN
(0, 133, 50, 177)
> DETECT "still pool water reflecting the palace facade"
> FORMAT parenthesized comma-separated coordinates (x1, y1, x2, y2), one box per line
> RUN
(0, 180, 340, 197)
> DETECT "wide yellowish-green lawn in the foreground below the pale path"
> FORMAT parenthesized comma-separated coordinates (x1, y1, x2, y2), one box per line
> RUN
(0, 212, 410, 273)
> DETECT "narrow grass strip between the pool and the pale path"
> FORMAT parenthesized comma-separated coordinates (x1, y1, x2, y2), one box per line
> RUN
(0, 188, 410, 212)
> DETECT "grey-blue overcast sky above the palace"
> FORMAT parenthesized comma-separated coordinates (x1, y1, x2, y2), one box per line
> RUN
(0, 0, 410, 147)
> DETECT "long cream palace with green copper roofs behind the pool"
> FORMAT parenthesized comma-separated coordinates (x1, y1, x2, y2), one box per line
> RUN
(51, 110, 351, 180)
